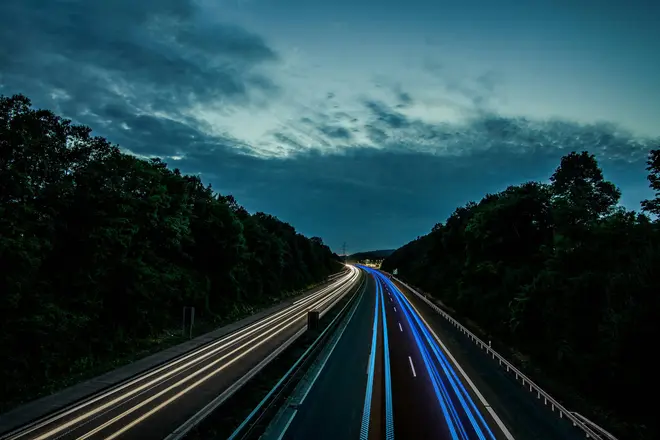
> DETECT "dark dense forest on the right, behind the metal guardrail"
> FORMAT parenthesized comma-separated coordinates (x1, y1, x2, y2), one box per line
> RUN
(383, 150, 660, 439)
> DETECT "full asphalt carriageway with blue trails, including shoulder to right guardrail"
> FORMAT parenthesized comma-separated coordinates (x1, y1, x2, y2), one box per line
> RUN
(282, 269, 581, 440)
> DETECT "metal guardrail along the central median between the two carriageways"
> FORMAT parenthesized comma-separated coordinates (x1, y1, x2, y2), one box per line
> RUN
(229, 277, 366, 440)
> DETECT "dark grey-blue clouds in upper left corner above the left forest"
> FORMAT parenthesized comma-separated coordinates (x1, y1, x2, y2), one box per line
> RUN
(0, 0, 278, 158)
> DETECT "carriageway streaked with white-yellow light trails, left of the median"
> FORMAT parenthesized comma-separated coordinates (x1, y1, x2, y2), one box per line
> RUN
(3, 267, 360, 440)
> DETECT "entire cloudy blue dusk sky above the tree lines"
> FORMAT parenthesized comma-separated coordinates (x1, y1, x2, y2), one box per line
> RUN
(0, 0, 660, 253)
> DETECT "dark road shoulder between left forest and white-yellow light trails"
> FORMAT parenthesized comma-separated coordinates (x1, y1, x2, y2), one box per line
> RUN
(0, 279, 340, 434)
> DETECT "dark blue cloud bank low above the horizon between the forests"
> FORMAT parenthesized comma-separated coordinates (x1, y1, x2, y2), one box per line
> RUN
(166, 106, 654, 249)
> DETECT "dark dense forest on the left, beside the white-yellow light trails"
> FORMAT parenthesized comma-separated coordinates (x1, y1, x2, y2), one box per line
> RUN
(0, 95, 342, 409)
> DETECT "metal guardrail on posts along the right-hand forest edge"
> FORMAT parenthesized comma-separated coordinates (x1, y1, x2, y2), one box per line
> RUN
(391, 275, 617, 440)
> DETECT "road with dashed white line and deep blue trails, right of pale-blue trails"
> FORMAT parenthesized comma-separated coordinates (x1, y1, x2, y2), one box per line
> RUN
(375, 272, 511, 440)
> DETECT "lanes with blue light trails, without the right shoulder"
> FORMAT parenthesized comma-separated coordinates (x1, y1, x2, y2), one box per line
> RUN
(268, 267, 513, 440)
